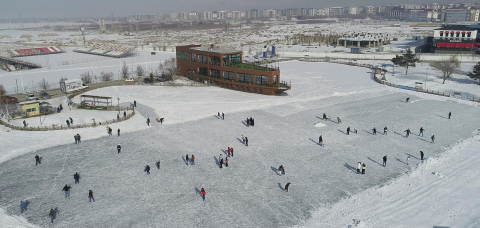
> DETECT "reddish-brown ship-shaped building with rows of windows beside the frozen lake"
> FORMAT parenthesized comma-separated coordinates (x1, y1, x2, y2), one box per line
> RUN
(176, 45, 291, 95)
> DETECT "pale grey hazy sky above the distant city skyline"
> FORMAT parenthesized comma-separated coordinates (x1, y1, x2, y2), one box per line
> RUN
(0, 0, 452, 18)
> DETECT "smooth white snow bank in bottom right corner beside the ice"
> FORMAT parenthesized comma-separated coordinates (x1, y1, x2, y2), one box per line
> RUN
(303, 134, 480, 228)
